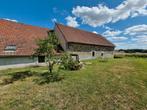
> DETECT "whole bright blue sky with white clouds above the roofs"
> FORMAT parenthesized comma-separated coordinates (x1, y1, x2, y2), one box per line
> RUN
(0, 0, 147, 49)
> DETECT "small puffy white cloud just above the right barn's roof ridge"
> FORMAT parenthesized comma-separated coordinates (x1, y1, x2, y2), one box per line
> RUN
(65, 16, 79, 27)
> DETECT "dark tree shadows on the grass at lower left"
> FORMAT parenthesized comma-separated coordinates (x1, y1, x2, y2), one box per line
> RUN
(1, 71, 63, 85)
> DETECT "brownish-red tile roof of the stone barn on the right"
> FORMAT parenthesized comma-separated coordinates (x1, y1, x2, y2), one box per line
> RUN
(56, 23, 115, 47)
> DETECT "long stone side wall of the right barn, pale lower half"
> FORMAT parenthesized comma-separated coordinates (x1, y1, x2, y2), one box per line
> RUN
(68, 43, 114, 60)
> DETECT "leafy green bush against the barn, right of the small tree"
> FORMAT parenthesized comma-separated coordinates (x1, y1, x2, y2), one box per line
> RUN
(60, 54, 82, 70)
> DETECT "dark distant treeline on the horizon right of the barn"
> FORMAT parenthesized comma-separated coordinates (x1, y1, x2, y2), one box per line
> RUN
(118, 49, 147, 53)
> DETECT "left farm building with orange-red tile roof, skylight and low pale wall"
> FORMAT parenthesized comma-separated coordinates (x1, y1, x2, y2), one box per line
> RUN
(0, 20, 49, 66)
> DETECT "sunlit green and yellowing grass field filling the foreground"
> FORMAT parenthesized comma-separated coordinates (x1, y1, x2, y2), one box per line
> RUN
(0, 58, 147, 110)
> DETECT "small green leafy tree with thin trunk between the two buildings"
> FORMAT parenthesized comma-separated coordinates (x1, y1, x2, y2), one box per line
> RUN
(35, 32, 59, 73)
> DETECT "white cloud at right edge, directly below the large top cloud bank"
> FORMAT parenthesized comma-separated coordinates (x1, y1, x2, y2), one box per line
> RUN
(125, 24, 147, 35)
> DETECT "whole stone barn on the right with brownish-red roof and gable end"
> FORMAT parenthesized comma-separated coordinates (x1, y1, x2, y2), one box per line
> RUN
(54, 23, 115, 60)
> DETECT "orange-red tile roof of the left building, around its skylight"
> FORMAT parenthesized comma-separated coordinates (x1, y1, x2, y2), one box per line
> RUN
(0, 20, 49, 56)
